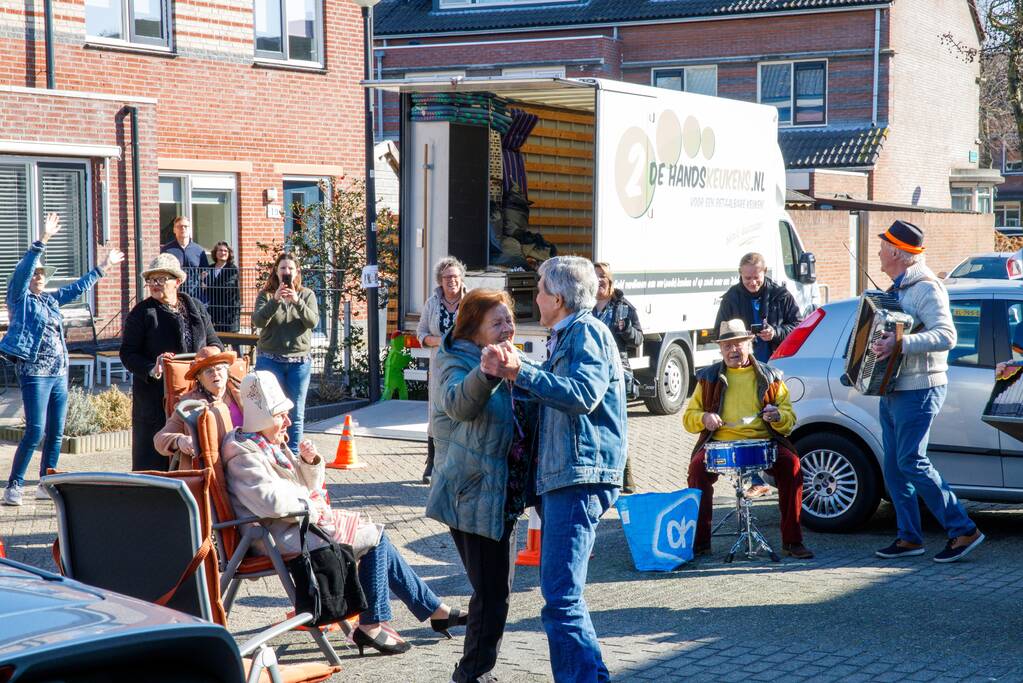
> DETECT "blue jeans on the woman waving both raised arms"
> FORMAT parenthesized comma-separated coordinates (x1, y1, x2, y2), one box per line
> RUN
(7, 374, 68, 486)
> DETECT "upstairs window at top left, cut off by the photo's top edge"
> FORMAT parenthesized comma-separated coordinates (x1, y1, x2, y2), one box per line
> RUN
(85, 0, 171, 47)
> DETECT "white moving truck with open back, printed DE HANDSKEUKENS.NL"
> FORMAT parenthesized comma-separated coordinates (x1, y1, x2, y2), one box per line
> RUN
(366, 78, 818, 414)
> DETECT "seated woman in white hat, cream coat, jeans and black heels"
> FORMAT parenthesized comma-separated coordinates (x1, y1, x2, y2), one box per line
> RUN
(221, 370, 466, 655)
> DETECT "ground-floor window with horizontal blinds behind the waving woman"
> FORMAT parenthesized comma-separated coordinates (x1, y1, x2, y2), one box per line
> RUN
(0, 158, 90, 297)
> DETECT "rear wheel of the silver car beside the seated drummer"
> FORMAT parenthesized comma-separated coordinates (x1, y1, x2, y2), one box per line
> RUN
(796, 434, 881, 532)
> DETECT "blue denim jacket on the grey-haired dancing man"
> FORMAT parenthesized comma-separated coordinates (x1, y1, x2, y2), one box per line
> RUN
(515, 311, 628, 495)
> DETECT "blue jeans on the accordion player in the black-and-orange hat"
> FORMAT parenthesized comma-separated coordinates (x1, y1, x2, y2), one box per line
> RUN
(880, 385, 977, 544)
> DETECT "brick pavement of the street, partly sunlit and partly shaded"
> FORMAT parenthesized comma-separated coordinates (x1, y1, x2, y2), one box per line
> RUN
(0, 408, 1023, 683)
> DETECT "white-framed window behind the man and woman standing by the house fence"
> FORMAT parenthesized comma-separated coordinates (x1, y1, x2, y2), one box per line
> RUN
(160, 174, 238, 261)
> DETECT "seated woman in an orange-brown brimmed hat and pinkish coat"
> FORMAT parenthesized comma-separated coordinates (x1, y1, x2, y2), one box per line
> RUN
(152, 347, 241, 469)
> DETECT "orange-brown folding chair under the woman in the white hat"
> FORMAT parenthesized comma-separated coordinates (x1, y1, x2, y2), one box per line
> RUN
(177, 401, 344, 664)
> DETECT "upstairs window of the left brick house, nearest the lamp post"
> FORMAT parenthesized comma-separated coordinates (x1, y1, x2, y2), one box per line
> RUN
(254, 0, 323, 66)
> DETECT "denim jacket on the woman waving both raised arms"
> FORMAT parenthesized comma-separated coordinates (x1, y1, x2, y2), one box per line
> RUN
(0, 240, 104, 361)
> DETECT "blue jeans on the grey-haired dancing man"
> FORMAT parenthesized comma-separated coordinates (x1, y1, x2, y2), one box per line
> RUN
(540, 484, 618, 683)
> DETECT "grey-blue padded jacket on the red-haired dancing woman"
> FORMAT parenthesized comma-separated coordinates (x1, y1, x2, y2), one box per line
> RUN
(427, 331, 515, 541)
